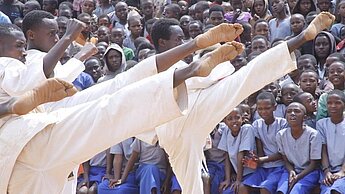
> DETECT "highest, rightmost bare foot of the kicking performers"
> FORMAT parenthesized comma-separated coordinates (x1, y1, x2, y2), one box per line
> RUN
(304, 12, 335, 41)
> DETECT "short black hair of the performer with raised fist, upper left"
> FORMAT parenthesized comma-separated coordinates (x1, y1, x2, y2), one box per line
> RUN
(22, 10, 54, 37)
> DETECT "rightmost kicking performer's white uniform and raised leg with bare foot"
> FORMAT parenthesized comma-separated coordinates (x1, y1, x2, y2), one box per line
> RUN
(125, 12, 334, 193)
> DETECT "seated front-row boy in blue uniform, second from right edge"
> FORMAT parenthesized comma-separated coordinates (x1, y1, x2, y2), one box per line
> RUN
(276, 102, 321, 194)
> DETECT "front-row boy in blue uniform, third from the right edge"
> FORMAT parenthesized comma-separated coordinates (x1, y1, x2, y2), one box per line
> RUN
(243, 92, 288, 193)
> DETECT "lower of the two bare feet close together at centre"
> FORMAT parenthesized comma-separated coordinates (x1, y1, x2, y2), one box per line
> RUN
(195, 41, 244, 77)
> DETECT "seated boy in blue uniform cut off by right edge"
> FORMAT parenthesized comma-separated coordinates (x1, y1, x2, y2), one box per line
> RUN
(316, 90, 345, 194)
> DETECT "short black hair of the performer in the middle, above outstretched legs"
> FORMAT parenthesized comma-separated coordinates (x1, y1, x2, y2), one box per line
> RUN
(151, 18, 180, 49)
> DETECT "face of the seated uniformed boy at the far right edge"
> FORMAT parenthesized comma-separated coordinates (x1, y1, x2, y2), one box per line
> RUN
(327, 94, 345, 118)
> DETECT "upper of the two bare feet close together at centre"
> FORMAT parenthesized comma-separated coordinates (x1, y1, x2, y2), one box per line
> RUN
(195, 23, 243, 49)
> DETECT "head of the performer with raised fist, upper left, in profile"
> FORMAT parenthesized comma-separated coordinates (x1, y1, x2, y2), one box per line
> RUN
(23, 10, 59, 52)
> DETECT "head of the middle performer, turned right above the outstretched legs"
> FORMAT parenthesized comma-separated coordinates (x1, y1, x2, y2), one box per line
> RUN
(151, 18, 184, 53)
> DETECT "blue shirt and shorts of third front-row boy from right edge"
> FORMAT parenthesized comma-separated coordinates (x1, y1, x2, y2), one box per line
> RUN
(243, 117, 288, 193)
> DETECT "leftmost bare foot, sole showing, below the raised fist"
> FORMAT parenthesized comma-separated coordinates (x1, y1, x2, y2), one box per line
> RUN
(10, 78, 77, 115)
